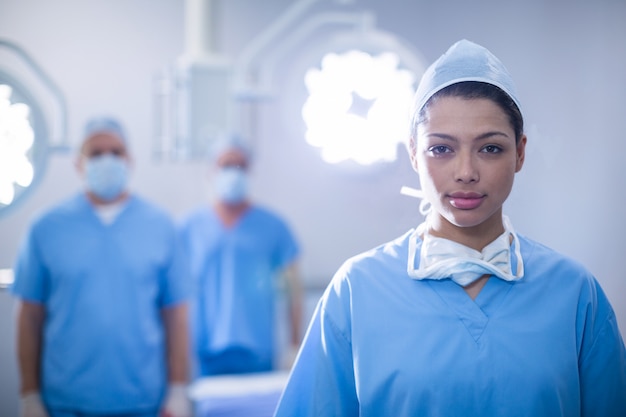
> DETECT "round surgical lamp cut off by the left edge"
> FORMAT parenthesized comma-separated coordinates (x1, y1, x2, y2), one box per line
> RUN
(0, 39, 67, 215)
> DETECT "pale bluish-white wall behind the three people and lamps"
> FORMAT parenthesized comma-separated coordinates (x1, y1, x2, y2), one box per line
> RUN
(0, 0, 626, 417)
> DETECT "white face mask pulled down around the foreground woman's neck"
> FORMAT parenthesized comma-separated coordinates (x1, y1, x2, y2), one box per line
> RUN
(407, 216, 524, 287)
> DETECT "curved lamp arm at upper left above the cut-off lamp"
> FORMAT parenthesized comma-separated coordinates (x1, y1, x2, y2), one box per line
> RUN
(0, 39, 69, 151)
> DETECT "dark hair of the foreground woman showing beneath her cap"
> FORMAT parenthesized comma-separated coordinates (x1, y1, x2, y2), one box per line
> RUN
(411, 81, 524, 143)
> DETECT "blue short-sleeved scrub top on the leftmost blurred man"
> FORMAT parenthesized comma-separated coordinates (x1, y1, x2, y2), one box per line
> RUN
(12, 194, 191, 413)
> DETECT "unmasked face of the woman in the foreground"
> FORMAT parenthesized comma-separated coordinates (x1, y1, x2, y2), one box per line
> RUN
(411, 97, 526, 239)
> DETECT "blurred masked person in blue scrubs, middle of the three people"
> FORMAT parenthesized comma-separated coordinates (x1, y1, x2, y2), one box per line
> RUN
(181, 135, 302, 376)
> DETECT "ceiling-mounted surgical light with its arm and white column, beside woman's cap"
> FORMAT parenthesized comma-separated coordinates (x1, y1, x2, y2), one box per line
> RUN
(154, 0, 424, 165)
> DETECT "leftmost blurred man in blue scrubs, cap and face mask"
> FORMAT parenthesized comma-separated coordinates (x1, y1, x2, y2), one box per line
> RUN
(12, 117, 191, 417)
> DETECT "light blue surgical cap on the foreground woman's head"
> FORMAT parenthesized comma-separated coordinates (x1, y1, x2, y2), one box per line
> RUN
(413, 39, 522, 118)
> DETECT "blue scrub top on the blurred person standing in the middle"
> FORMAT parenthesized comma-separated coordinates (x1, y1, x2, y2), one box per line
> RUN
(181, 206, 299, 372)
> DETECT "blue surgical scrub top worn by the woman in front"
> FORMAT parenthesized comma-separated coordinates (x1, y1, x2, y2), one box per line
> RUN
(276, 232, 626, 417)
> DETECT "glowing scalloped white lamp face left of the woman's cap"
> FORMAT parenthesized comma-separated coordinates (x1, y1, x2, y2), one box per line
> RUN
(302, 50, 415, 165)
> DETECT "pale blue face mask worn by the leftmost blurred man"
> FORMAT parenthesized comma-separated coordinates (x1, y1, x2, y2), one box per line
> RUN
(85, 154, 128, 201)
